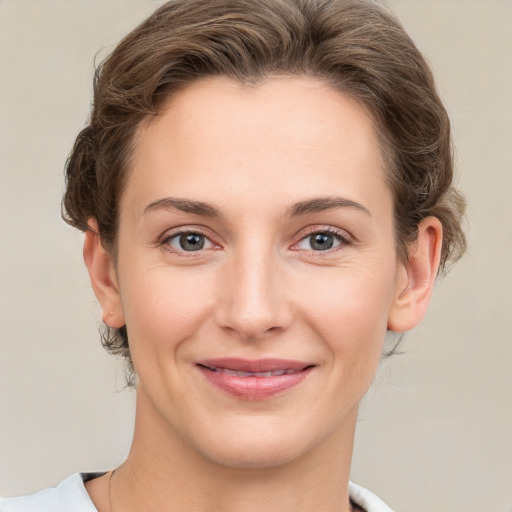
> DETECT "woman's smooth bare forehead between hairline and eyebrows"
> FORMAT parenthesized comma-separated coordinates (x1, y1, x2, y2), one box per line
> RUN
(123, 78, 387, 217)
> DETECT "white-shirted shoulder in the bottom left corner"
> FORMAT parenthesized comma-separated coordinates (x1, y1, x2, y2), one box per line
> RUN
(0, 473, 100, 512)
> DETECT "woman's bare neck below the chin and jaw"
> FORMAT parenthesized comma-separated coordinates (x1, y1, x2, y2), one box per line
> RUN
(112, 390, 357, 512)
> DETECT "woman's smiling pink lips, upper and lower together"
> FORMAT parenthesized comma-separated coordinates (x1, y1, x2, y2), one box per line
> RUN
(196, 358, 315, 400)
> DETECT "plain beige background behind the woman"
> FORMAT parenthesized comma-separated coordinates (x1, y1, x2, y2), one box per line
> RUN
(0, 0, 512, 512)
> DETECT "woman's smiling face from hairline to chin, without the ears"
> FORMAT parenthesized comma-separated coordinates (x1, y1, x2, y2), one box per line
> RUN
(107, 78, 406, 467)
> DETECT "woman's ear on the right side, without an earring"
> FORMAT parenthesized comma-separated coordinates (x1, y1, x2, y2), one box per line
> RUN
(388, 217, 443, 332)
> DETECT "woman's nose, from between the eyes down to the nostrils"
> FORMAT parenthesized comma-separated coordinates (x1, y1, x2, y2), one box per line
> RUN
(216, 247, 293, 340)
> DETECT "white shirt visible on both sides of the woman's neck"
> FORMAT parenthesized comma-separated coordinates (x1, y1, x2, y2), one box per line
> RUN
(0, 473, 393, 512)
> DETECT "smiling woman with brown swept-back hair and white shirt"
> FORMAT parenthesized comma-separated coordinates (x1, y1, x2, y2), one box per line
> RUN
(0, 0, 464, 512)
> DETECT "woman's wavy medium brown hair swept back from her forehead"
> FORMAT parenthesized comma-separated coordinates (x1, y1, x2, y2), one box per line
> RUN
(63, 0, 466, 376)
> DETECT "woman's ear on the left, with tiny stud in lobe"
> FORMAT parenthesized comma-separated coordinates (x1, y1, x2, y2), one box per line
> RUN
(83, 218, 125, 327)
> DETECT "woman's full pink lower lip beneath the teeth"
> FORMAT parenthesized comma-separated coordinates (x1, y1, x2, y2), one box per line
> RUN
(197, 366, 313, 400)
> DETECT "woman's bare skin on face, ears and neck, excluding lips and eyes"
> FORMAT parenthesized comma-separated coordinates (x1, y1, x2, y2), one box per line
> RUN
(84, 78, 442, 512)
